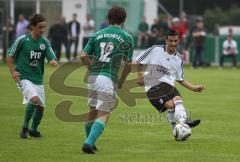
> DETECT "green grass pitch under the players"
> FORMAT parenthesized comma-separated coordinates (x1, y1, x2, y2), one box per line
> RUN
(0, 64, 240, 162)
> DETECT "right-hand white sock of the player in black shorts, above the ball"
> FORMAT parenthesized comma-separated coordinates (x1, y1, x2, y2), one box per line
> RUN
(174, 100, 187, 123)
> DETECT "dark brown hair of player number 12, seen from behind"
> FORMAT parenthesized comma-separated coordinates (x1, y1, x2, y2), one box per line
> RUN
(108, 6, 127, 25)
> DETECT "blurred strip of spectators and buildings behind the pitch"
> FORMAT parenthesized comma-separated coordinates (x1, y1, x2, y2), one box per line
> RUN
(0, 0, 240, 68)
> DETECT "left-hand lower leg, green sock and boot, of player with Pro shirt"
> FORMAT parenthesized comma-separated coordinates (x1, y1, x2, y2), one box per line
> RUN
(20, 103, 34, 138)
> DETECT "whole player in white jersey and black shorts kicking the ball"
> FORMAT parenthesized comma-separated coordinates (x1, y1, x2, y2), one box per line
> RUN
(136, 30, 204, 127)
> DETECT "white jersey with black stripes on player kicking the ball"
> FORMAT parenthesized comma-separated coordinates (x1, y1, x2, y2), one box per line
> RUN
(136, 45, 184, 91)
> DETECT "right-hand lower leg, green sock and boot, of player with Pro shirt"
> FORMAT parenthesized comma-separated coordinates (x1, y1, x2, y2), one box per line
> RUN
(29, 106, 44, 138)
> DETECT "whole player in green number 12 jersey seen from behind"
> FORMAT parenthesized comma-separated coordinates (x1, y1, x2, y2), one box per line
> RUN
(81, 6, 134, 154)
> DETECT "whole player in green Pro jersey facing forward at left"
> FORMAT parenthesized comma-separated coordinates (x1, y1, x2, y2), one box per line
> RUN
(7, 14, 58, 138)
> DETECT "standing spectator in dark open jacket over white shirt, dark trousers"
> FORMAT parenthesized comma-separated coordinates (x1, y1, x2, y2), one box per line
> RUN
(67, 13, 81, 60)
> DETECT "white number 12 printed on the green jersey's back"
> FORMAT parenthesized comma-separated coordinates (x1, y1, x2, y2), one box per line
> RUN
(99, 42, 114, 62)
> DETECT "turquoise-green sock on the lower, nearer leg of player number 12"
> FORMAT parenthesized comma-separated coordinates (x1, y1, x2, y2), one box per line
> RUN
(84, 119, 106, 146)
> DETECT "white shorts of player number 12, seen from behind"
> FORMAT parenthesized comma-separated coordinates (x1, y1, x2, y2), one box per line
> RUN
(88, 75, 116, 112)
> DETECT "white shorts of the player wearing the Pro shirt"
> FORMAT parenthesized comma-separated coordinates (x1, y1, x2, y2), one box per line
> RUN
(17, 79, 45, 107)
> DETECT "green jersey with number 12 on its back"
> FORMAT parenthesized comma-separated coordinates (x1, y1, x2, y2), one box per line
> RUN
(84, 26, 134, 83)
